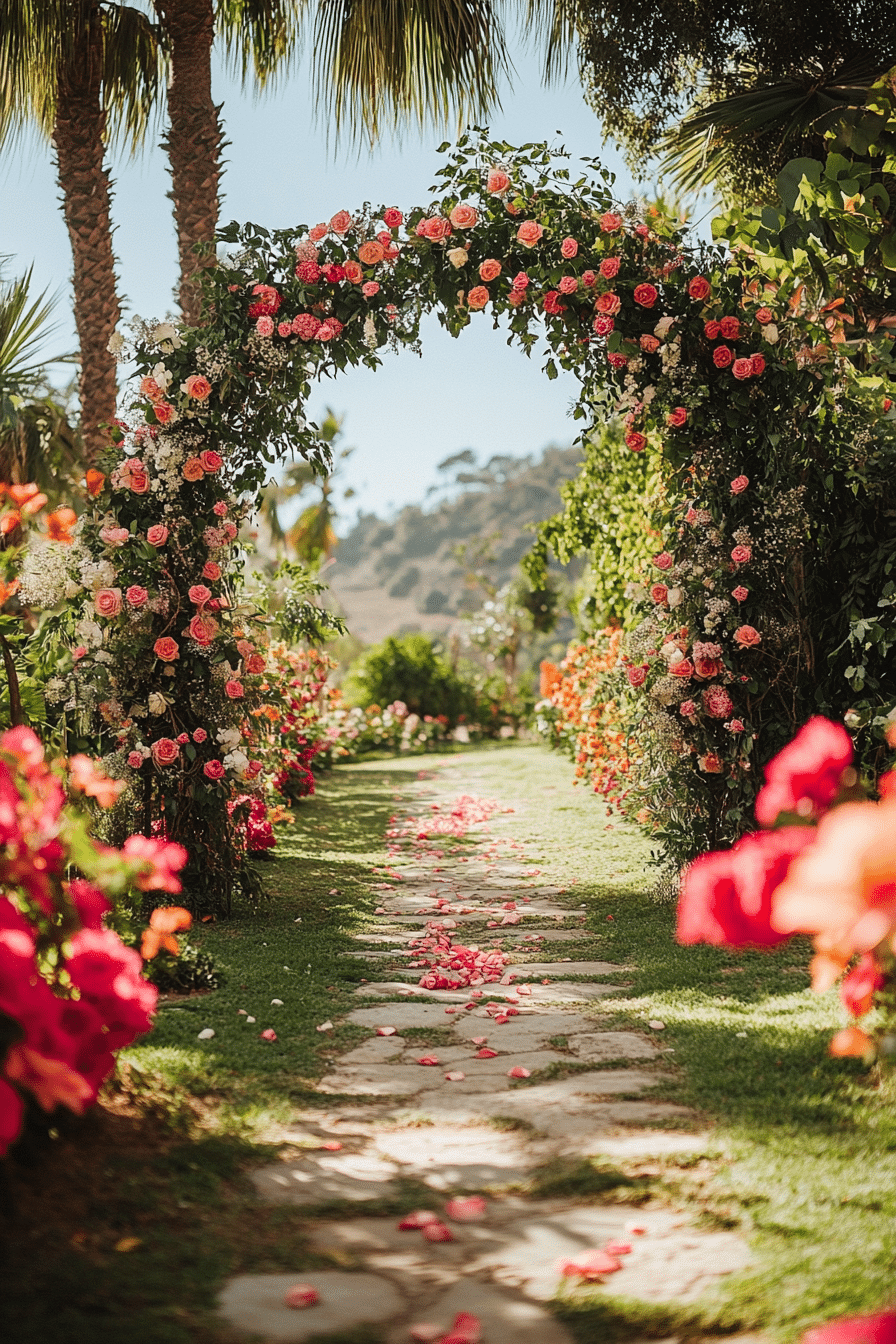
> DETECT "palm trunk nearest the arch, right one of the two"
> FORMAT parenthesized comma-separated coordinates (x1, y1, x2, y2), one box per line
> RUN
(154, 0, 223, 325)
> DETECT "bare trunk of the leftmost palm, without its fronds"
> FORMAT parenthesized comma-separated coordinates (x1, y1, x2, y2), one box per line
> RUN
(52, 4, 121, 460)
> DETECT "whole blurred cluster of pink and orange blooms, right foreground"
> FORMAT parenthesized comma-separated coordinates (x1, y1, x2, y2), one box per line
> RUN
(678, 718, 896, 1055)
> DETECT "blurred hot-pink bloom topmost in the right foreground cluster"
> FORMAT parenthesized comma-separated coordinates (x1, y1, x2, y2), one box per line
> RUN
(756, 715, 853, 827)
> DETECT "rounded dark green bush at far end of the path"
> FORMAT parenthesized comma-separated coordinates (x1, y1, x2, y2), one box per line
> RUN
(345, 634, 474, 723)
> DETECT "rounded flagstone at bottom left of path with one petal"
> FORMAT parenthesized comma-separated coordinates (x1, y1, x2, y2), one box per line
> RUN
(218, 1270, 406, 1344)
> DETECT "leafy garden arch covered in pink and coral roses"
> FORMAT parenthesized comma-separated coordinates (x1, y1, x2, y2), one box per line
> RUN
(43, 134, 893, 909)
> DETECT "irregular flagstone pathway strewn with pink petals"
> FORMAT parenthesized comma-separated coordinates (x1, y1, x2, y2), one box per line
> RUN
(220, 758, 750, 1344)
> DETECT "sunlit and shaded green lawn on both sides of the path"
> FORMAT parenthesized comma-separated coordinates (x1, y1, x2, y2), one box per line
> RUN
(0, 746, 896, 1344)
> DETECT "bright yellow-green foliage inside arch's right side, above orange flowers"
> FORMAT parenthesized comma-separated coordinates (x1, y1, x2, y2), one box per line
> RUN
(523, 421, 661, 630)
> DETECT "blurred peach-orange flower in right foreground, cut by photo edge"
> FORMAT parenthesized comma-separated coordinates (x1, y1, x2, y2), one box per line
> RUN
(771, 796, 896, 993)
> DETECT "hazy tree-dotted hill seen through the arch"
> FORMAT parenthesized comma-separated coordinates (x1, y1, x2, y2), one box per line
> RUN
(326, 448, 582, 642)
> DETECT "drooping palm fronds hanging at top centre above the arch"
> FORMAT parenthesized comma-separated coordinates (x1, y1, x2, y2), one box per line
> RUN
(313, 0, 510, 141)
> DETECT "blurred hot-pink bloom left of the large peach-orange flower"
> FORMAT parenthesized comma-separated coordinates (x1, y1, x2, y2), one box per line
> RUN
(678, 822, 814, 948)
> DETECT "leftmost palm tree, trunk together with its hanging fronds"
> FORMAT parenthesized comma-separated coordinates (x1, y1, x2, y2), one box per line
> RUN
(0, 0, 161, 457)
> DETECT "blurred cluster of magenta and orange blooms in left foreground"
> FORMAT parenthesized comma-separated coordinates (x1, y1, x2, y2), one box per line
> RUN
(0, 727, 189, 1152)
